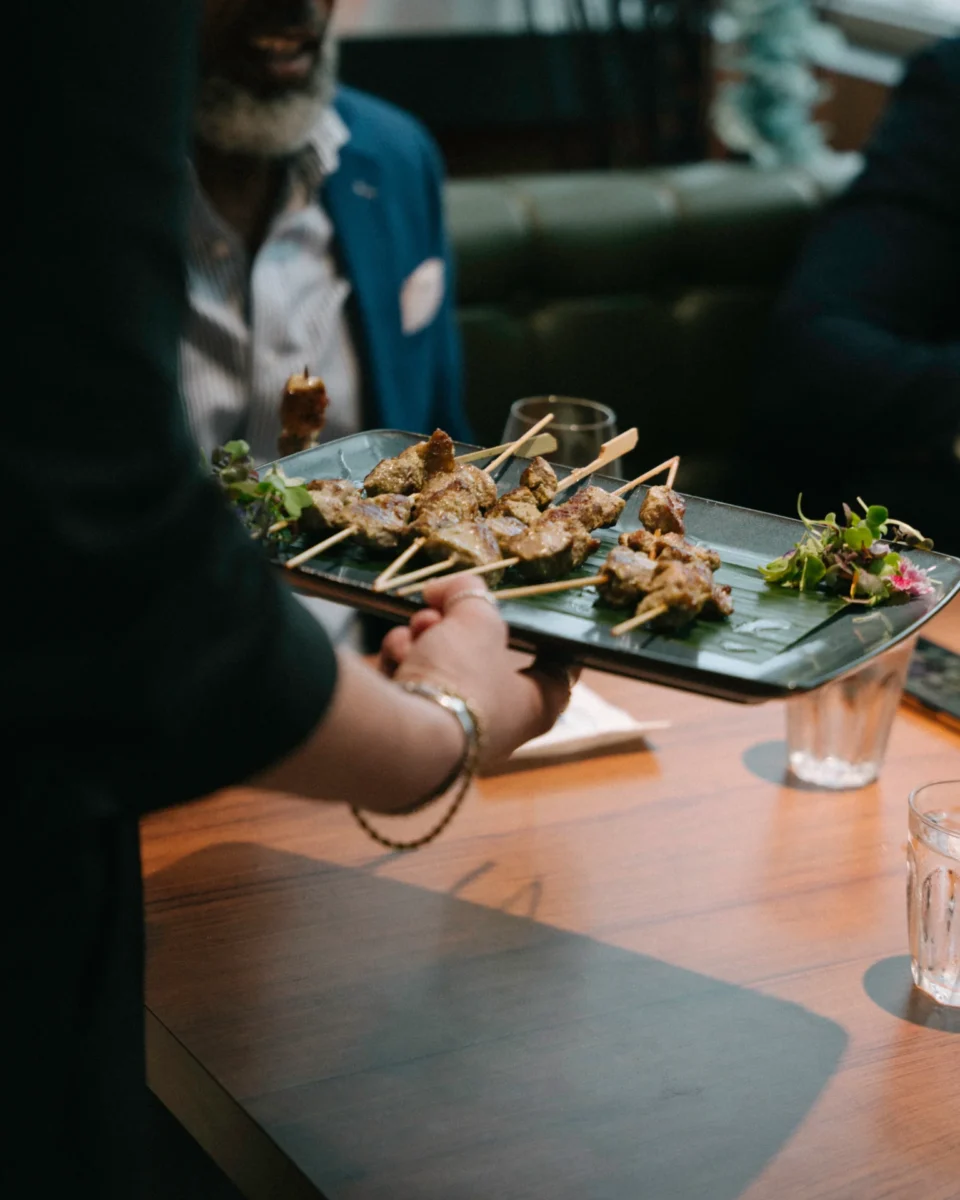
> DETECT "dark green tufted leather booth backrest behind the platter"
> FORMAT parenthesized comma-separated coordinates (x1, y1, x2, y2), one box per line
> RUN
(448, 160, 856, 498)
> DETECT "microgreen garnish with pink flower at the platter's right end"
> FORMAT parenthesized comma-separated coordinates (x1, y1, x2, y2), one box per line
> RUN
(760, 496, 934, 605)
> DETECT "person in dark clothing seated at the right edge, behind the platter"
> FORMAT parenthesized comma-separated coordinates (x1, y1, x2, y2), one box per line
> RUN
(736, 38, 960, 552)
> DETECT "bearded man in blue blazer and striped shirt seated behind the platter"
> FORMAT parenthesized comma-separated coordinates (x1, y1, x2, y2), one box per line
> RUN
(181, 0, 468, 462)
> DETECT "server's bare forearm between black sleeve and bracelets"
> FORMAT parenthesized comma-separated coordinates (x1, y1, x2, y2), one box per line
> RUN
(250, 652, 464, 812)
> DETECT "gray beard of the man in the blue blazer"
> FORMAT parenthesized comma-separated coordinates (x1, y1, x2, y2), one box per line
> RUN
(193, 31, 338, 158)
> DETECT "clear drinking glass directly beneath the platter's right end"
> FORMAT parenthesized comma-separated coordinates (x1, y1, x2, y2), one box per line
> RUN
(787, 637, 917, 788)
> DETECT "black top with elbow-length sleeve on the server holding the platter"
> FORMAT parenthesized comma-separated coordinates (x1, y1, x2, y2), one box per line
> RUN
(0, 0, 336, 828)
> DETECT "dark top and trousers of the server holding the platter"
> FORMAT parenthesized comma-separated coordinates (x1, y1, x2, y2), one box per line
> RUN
(0, 0, 336, 1200)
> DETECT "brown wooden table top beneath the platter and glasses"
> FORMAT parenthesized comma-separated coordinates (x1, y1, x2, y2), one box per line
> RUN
(143, 602, 960, 1200)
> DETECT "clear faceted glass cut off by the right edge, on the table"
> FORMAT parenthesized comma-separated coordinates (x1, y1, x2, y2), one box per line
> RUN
(907, 779, 960, 1008)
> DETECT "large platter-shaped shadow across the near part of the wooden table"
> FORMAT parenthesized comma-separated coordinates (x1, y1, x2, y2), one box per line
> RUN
(148, 845, 846, 1200)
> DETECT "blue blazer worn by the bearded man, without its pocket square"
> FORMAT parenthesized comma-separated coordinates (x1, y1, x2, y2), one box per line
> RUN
(320, 88, 470, 440)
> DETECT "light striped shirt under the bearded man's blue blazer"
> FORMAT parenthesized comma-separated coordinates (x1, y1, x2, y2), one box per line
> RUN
(180, 108, 361, 463)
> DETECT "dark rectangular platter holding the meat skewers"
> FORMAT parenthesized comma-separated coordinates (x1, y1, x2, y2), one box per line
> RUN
(260, 430, 960, 703)
